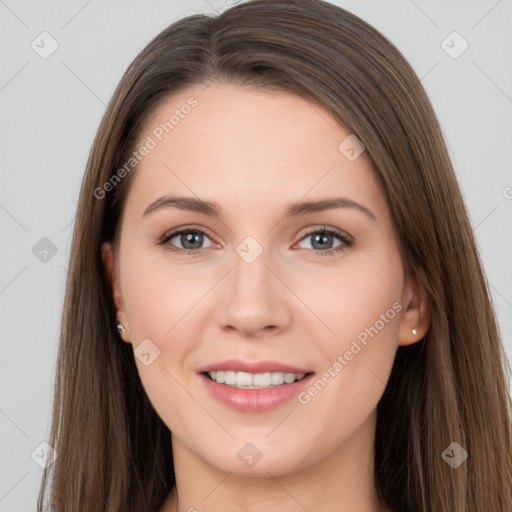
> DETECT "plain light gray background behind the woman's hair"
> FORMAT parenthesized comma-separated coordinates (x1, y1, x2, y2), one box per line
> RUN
(0, 0, 512, 512)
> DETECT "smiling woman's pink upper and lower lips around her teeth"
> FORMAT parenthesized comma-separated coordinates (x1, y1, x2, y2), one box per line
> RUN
(199, 359, 315, 412)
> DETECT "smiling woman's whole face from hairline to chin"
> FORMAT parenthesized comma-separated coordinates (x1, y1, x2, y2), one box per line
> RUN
(103, 84, 421, 476)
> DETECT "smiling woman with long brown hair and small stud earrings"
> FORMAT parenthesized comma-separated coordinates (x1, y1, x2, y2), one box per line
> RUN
(38, 0, 512, 512)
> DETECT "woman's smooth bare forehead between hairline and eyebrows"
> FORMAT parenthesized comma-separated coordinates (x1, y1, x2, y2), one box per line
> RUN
(128, 84, 385, 219)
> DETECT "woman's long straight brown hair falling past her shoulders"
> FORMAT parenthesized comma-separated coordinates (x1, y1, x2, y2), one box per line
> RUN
(38, 0, 512, 512)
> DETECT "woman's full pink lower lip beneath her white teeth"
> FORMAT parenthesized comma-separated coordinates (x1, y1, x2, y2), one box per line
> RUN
(199, 373, 315, 412)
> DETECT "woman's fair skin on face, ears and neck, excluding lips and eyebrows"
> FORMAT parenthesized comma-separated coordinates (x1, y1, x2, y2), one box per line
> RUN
(102, 83, 430, 512)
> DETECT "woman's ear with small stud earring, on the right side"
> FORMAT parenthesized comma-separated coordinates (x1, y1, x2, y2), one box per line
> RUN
(398, 273, 431, 346)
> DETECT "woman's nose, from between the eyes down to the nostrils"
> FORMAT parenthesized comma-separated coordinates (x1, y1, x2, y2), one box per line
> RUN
(216, 251, 293, 338)
